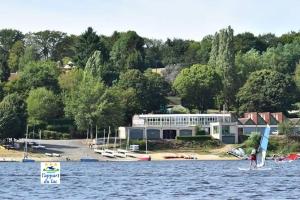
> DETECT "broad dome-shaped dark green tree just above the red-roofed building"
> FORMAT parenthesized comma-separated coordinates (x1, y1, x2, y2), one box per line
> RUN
(237, 70, 295, 112)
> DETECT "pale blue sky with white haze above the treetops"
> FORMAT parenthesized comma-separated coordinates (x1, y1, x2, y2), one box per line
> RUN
(0, 0, 300, 41)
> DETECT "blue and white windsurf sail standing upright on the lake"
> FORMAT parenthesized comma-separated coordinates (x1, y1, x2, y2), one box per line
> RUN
(256, 125, 271, 167)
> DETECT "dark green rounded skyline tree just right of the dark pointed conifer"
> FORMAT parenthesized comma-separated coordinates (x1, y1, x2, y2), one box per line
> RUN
(110, 31, 145, 72)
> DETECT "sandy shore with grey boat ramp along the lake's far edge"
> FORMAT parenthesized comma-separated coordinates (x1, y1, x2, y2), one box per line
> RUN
(0, 140, 238, 162)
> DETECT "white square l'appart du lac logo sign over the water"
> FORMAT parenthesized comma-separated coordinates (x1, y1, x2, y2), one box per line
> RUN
(41, 162, 60, 184)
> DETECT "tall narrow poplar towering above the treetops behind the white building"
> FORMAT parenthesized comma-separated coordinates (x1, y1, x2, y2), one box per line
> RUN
(209, 26, 238, 109)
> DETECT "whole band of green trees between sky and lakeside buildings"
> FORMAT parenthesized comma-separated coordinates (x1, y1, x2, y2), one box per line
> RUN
(0, 27, 300, 138)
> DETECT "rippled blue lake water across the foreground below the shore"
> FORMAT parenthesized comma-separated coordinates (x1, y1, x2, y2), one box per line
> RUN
(0, 161, 300, 200)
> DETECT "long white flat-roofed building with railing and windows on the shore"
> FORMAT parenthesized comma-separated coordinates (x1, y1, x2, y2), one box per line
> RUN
(119, 113, 237, 143)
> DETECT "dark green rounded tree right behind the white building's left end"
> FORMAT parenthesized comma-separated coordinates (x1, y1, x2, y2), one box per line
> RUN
(116, 69, 169, 119)
